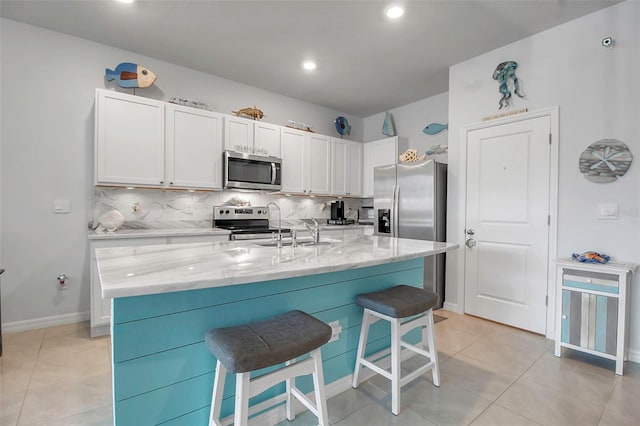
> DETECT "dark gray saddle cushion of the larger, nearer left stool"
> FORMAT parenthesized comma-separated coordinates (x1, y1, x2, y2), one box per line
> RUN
(205, 311, 331, 373)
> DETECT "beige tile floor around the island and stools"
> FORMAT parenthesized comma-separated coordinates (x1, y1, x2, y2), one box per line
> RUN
(0, 311, 640, 426)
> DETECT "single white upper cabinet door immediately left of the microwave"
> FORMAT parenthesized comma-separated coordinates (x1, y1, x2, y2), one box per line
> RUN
(165, 104, 224, 189)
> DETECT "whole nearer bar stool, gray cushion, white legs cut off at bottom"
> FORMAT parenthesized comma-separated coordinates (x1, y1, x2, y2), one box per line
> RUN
(205, 311, 331, 426)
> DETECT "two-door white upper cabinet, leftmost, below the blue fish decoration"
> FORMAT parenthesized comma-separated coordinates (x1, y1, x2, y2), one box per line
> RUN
(95, 89, 223, 189)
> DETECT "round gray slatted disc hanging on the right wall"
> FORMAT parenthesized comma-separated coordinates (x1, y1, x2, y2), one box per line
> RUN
(580, 139, 633, 183)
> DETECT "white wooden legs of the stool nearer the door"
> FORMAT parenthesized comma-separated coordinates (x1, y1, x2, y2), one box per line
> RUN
(352, 308, 440, 415)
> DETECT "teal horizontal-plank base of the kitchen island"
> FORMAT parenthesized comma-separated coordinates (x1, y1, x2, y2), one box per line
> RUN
(111, 258, 424, 426)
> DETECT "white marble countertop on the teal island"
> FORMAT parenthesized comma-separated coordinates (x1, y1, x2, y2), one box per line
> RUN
(96, 235, 458, 298)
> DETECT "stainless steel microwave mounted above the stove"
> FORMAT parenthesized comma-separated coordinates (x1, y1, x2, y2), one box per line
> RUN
(224, 151, 282, 191)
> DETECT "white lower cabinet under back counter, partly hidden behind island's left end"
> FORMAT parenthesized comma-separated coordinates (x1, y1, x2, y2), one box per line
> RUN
(89, 234, 229, 337)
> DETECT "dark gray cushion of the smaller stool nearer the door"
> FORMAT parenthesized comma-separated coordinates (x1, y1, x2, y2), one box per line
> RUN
(356, 285, 438, 318)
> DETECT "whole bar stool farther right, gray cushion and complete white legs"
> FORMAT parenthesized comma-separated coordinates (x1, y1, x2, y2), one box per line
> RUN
(352, 285, 440, 415)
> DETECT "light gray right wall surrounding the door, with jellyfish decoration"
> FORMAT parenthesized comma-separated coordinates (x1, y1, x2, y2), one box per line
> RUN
(447, 1, 640, 361)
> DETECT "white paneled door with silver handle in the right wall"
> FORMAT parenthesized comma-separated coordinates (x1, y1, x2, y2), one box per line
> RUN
(464, 116, 551, 333)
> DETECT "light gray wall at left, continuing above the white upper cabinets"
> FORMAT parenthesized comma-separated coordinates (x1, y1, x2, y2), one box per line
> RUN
(0, 19, 363, 327)
